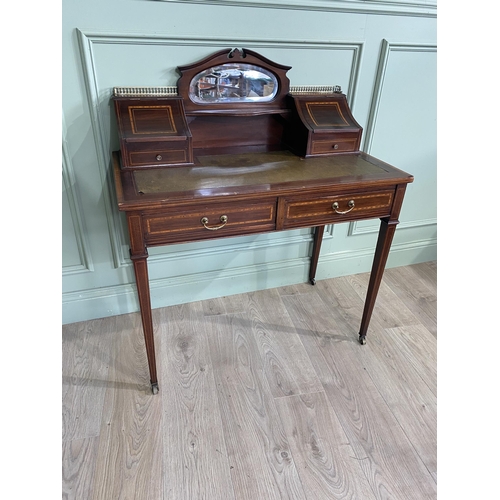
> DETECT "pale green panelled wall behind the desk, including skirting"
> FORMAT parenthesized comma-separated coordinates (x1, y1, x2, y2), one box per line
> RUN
(62, 0, 437, 323)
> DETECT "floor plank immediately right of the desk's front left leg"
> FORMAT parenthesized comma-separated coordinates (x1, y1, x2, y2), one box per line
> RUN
(159, 301, 234, 500)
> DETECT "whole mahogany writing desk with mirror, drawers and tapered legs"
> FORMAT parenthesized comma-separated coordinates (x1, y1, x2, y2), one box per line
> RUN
(112, 51, 413, 394)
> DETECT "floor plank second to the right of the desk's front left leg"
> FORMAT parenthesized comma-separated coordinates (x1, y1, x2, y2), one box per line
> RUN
(209, 315, 305, 500)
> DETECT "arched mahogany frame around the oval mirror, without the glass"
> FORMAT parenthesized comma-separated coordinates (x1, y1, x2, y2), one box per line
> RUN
(177, 49, 291, 115)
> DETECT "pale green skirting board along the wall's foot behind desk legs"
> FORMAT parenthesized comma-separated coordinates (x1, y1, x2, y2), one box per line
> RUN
(62, 240, 437, 324)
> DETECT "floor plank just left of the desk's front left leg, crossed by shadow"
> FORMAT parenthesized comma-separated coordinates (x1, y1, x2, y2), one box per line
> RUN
(90, 314, 163, 500)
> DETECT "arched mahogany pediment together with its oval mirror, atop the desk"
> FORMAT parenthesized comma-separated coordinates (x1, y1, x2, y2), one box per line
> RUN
(177, 48, 291, 114)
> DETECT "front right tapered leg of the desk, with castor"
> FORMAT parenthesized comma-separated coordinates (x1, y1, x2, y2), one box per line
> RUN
(359, 219, 399, 344)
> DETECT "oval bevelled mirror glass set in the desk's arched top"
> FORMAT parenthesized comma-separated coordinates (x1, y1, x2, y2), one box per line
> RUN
(189, 63, 278, 104)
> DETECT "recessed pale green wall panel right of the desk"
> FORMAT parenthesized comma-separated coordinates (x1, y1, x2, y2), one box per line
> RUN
(365, 42, 437, 224)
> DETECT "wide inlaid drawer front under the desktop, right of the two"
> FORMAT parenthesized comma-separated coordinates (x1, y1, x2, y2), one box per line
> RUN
(280, 190, 394, 229)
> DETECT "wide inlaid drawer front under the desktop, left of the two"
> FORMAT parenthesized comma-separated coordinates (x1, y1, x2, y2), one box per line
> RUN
(143, 198, 276, 244)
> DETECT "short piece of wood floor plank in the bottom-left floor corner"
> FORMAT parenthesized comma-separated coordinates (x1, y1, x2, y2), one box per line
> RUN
(62, 437, 99, 500)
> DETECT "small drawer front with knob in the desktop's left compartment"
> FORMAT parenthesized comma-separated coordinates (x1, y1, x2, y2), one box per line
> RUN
(125, 140, 192, 167)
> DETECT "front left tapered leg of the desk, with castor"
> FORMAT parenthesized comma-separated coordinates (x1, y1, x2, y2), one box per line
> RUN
(130, 253, 159, 394)
